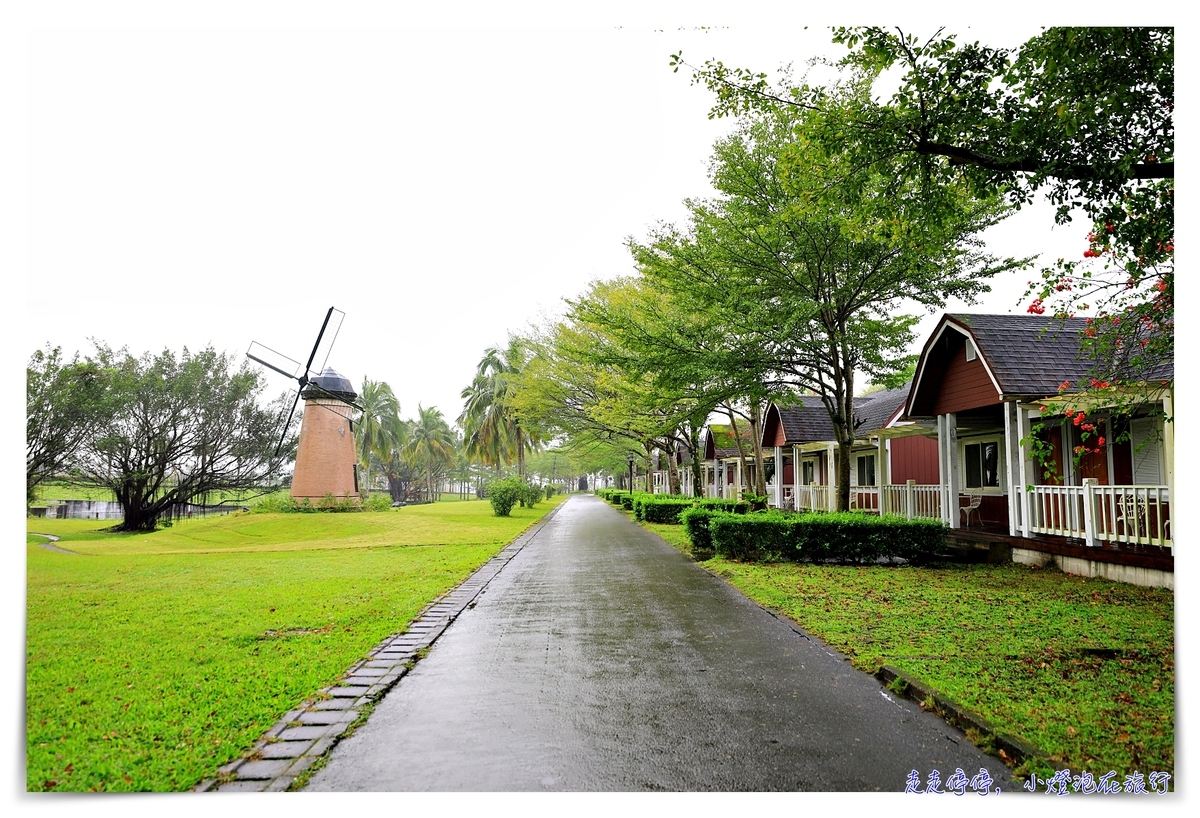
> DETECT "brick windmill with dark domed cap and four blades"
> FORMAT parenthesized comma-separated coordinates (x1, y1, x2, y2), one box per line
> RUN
(246, 307, 360, 500)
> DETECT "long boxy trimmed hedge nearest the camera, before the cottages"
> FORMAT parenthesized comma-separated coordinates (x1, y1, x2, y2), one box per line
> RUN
(683, 509, 946, 564)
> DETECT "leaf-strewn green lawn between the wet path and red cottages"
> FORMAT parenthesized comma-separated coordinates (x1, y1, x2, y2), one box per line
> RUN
(646, 515, 1175, 781)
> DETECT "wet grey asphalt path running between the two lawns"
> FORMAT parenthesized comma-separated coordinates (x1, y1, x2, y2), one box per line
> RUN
(307, 495, 1013, 794)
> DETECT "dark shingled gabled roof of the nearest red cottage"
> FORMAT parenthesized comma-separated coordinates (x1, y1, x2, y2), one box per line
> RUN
(908, 313, 1175, 417)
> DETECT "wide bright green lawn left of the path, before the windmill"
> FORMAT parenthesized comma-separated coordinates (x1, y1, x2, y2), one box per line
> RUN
(26, 497, 564, 790)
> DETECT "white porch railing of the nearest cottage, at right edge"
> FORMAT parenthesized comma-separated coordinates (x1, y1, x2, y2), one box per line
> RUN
(1026, 481, 1172, 548)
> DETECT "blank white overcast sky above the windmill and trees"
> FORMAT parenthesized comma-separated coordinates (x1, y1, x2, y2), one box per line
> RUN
(11, 1, 1104, 421)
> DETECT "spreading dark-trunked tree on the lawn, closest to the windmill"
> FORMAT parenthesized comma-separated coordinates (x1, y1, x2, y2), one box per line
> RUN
(78, 347, 288, 531)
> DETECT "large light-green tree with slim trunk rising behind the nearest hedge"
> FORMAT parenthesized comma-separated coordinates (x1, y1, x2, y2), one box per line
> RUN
(631, 77, 1019, 509)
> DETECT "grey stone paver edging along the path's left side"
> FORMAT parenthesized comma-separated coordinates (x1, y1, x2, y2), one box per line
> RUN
(194, 503, 564, 793)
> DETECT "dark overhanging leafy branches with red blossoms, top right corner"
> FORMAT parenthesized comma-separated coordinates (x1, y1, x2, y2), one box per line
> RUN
(672, 26, 1175, 403)
